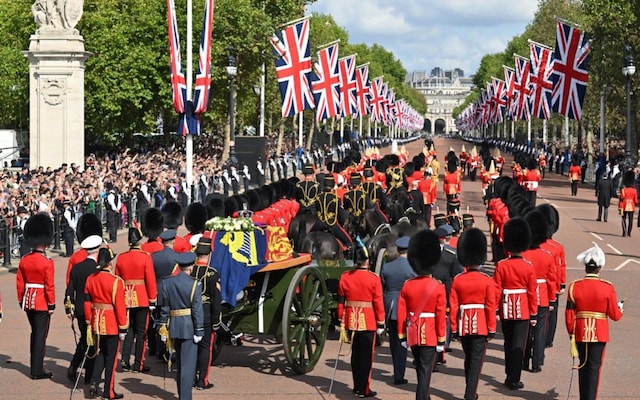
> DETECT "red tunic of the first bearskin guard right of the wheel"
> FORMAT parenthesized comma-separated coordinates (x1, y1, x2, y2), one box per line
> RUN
(398, 276, 447, 346)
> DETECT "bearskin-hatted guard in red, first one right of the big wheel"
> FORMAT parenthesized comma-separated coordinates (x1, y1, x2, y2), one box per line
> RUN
(397, 230, 447, 399)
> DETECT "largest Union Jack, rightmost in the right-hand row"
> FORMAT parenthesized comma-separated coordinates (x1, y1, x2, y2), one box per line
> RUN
(551, 21, 591, 121)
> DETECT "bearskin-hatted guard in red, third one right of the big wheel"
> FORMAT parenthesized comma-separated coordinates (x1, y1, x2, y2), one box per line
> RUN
(493, 217, 538, 390)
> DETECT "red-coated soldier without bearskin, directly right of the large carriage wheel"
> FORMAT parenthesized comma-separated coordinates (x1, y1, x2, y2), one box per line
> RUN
(338, 243, 385, 397)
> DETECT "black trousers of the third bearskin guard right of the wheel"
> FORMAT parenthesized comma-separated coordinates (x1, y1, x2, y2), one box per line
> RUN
(501, 319, 529, 384)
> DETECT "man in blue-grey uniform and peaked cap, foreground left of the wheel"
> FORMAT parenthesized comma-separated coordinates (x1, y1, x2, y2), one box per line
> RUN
(159, 252, 204, 400)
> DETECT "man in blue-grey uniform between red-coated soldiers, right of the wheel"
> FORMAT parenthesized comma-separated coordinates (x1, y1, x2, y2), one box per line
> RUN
(380, 236, 416, 385)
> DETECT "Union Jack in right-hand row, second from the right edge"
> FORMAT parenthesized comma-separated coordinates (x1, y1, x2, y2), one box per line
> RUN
(529, 40, 553, 120)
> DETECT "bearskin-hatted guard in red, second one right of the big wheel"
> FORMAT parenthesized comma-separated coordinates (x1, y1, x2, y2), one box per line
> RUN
(449, 228, 496, 400)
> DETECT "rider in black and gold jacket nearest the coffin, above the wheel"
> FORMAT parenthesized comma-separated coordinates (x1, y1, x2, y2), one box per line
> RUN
(311, 175, 353, 251)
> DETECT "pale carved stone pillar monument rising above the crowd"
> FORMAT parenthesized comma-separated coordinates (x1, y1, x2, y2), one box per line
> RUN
(23, 0, 90, 169)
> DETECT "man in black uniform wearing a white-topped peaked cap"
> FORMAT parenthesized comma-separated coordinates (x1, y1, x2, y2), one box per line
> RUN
(64, 235, 102, 383)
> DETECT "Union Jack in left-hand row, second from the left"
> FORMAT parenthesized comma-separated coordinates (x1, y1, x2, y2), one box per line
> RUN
(313, 43, 340, 121)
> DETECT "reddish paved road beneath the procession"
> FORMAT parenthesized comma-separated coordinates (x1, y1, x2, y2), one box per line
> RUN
(0, 139, 640, 400)
